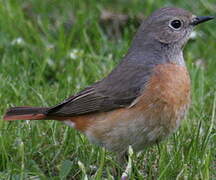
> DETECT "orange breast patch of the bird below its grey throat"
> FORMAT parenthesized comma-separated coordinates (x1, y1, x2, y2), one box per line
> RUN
(135, 64, 190, 129)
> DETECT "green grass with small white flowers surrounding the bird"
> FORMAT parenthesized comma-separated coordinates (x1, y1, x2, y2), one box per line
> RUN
(0, 0, 216, 180)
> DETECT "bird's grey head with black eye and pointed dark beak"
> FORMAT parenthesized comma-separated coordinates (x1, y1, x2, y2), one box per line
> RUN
(126, 7, 214, 65)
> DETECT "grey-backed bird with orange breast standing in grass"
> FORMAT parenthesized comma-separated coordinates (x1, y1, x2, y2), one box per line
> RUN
(3, 7, 214, 155)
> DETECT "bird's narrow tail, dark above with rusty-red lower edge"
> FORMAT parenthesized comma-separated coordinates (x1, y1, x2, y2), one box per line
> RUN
(3, 107, 48, 121)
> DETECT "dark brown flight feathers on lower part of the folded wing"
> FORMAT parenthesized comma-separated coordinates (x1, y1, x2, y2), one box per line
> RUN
(47, 87, 132, 116)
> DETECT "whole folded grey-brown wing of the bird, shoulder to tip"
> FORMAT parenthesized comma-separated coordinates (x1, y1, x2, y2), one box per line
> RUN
(46, 61, 149, 116)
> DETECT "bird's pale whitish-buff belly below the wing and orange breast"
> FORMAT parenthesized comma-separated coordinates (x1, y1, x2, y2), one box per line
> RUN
(85, 101, 187, 153)
